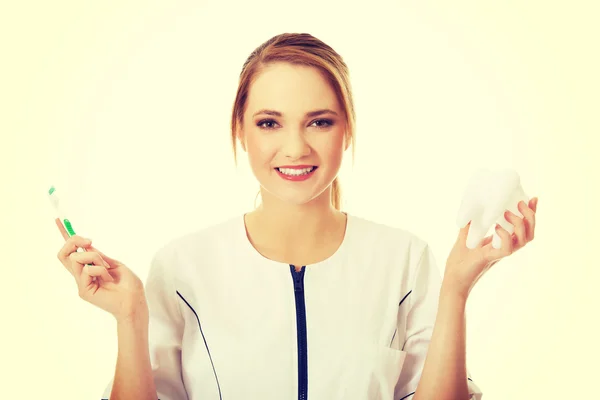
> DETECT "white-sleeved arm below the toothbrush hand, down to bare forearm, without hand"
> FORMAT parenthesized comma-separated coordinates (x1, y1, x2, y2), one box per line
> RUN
(102, 249, 188, 400)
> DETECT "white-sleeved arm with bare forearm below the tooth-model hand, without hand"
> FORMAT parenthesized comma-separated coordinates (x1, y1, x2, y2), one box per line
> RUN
(397, 246, 483, 400)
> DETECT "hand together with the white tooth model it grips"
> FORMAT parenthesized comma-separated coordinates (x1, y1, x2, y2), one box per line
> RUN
(444, 169, 537, 299)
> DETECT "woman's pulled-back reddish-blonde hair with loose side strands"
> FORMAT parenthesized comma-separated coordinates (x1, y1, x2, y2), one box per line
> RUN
(231, 33, 356, 210)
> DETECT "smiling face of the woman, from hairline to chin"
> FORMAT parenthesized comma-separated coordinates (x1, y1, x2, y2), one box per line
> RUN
(238, 63, 348, 204)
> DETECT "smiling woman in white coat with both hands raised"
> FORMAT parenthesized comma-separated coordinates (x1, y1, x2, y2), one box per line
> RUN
(57, 34, 537, 400)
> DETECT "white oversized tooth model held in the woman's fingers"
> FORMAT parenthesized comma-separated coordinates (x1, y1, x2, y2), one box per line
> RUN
(456, 169, 529, 249)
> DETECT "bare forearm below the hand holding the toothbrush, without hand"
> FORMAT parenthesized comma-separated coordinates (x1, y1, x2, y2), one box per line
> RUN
(110, 308, 158, 400)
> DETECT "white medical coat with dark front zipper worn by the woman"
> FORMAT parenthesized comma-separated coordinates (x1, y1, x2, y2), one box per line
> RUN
(102, 214, 482, 400)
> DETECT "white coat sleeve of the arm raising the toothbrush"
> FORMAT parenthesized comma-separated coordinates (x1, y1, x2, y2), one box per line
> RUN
(102, 248, 188, 400)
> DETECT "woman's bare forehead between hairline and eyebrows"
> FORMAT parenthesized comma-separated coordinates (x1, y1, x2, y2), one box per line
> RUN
(247, 63, 340, 116)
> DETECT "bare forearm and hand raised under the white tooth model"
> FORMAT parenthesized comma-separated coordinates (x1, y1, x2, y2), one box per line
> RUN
(414, 197, 537, 400)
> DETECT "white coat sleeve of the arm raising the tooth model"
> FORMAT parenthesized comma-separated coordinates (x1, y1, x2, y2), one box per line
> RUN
(395, 244, 483, 400)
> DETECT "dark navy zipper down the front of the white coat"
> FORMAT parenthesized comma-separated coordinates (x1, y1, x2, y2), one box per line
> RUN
(290, 264, 308, 400)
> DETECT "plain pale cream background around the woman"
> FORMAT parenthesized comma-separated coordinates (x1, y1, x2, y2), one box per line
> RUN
(0, 1, 600, 400)
